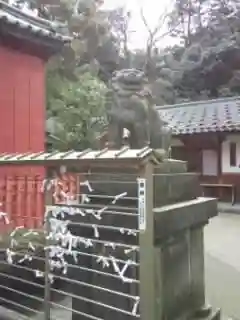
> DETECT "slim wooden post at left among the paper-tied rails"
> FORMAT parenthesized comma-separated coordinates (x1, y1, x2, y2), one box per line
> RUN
(44, 182, 53, 320)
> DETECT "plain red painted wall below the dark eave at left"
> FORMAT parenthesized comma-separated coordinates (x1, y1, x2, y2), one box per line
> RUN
(0, 47, 45, 153)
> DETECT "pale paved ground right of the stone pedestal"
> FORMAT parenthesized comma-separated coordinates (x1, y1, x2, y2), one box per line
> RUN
(205, 214, 240, 320)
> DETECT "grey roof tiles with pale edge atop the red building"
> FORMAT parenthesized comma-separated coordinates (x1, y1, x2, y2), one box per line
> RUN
(0, 0, 70, 41)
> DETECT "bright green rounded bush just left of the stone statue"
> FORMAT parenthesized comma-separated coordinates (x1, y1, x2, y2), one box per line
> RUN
(47, 72, 106, 150)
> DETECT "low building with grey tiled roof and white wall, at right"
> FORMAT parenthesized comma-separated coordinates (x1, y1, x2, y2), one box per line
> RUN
(158, 97, 240, 203)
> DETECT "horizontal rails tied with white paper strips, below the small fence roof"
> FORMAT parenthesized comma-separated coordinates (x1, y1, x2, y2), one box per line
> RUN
(0, 171, 140, 320)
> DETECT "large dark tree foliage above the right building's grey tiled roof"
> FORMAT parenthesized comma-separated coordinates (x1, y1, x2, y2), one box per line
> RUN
(167, 0, 240, 100)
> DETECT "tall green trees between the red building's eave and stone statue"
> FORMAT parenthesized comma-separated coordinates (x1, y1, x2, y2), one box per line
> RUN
(43, 0, 118, 150)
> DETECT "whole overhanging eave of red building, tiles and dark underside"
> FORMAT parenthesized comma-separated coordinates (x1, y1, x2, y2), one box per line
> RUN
(0, 0, 71, 58)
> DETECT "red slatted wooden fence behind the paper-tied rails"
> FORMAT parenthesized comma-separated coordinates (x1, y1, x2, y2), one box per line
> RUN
(0, 173, 78, 232)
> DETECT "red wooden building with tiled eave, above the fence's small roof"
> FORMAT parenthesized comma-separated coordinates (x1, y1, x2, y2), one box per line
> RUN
(0, 1, 67, 156)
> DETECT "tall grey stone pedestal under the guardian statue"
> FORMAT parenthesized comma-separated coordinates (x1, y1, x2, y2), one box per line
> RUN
(153, 160, 220, 320)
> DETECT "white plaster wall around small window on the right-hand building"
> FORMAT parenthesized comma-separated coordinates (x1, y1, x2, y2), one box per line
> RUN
(222, 135, 240, 173)
